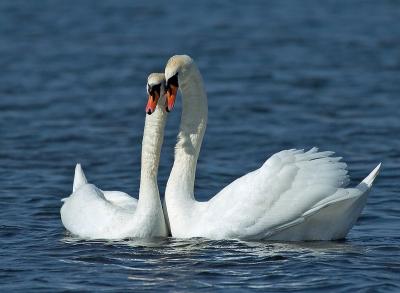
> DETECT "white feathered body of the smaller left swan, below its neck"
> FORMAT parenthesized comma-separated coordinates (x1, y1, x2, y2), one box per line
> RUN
(61, 165, 168, 239)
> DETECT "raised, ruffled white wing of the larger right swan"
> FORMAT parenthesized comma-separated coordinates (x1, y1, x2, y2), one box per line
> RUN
(196, 148, 349, 239)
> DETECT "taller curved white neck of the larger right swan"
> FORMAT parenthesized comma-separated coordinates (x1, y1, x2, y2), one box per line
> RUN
(165, 63, 208, 202)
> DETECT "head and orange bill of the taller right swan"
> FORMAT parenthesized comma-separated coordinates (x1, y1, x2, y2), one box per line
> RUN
(165, 55, 194, 112)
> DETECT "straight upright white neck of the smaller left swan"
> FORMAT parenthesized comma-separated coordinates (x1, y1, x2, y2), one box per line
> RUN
(139, 106, 167, 206)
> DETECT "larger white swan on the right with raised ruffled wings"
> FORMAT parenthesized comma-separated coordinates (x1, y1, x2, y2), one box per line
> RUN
(159, 55, 380, 241)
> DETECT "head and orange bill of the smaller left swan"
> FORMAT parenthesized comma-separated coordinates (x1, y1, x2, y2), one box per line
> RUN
(146, 73, 166, 115)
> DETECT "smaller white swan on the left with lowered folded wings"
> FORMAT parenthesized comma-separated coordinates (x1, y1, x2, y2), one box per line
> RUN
(61, 73, 168, 239)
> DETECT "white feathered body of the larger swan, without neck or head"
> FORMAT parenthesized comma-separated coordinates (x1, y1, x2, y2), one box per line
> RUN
(168, 148, 380, 241)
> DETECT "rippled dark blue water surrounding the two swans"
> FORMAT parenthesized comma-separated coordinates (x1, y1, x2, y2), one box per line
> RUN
(0, 0, 400, 292)
